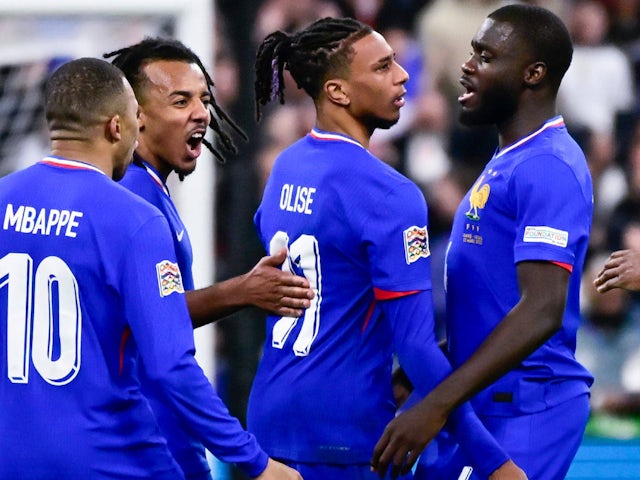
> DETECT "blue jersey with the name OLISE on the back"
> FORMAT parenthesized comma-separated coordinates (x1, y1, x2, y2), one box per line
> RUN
(247, 129, 504, 474)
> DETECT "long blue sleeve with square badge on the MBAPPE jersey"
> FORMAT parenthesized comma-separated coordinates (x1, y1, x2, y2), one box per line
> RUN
(121, 216, 268, 477)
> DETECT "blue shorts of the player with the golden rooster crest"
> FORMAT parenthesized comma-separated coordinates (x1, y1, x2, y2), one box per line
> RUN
(414, 393, 589, 480)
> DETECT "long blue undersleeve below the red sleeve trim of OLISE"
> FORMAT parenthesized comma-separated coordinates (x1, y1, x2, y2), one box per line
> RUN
(381, 291, 509, 477)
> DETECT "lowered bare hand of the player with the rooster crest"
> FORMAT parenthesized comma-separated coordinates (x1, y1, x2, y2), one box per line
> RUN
(371, 400, 447, 478)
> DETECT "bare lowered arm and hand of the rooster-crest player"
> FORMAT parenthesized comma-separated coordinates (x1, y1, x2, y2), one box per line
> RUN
(372, 262, 569, 478)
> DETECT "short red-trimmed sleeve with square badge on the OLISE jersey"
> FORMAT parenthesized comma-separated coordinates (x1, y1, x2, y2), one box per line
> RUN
(362, 182, 431, 292)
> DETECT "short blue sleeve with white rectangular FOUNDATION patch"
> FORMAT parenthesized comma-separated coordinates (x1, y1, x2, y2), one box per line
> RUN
(509, 155, 592, 266)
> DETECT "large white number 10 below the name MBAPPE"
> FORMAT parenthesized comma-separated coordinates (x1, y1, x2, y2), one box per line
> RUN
(0, 253, 82, 385)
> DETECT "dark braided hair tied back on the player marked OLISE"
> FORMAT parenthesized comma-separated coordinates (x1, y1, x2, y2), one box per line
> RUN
(254, 17, 373, 121)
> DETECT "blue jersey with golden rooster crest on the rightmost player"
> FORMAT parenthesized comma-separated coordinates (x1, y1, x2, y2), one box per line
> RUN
(445, 117, 593, 415)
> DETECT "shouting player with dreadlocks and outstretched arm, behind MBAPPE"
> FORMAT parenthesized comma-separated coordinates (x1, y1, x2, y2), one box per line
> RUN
(105, 38, 313, 480)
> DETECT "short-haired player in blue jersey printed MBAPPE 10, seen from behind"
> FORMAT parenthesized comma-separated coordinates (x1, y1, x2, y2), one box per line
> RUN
(0, 58, 301, 480)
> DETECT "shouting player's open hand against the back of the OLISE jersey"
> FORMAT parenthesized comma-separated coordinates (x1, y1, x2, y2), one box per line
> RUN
(242, 248, 314, 317)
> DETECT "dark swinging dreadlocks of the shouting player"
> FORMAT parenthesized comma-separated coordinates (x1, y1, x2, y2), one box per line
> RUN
(103, 37, 248, 167)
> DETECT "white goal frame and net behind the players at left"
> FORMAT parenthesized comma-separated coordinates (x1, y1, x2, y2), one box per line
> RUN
(0, 0, 215, 379)
